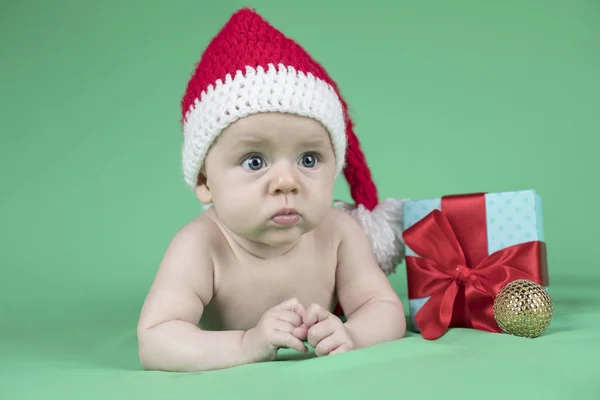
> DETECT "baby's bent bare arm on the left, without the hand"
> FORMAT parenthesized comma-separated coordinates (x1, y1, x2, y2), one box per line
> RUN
(137, 221, 249, 371)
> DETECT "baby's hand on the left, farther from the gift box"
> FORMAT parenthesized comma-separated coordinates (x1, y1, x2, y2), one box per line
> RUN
(242, 299, 308, 362)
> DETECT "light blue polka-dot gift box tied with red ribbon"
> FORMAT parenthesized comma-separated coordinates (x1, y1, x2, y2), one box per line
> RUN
(403, 190, 548, 339)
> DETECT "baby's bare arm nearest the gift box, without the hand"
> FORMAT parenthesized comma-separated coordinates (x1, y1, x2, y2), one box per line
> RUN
(336, 209, 406, 348)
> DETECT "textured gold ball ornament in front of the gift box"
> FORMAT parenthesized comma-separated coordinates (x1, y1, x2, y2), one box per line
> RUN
(494, 279, 554, 338)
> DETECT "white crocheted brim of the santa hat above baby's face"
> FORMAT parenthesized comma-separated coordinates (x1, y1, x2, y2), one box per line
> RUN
(182, 64, 347, 189)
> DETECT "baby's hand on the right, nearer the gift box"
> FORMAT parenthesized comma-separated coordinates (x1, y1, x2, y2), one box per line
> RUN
(304, 304, 354, 356)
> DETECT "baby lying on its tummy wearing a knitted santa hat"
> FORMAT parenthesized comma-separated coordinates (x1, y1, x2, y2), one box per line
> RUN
(138, 9, 405, 371)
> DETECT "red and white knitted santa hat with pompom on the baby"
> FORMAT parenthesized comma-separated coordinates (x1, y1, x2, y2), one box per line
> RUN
(181, 8, 404, 275)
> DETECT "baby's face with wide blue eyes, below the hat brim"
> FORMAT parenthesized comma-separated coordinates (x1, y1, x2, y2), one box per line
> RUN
(198, 113, 335, 245)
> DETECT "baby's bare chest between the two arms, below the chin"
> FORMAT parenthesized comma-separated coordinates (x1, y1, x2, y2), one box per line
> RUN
(200, 212, 340, 330)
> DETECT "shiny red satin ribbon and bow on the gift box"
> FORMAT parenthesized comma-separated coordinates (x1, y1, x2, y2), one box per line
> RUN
(403, 193, 548, 340)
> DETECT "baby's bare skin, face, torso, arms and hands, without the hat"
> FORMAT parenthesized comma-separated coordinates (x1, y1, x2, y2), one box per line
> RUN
(138, 114, 405, 371)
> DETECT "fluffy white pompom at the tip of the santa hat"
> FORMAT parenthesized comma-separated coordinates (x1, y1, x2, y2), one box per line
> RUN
(334, 198, 405, 276)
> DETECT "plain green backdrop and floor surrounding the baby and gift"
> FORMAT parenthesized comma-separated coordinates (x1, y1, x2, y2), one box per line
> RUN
(0, 0, 600, 400)
